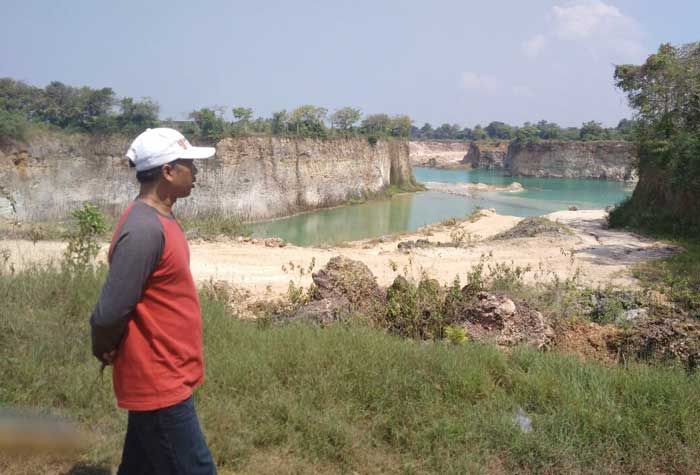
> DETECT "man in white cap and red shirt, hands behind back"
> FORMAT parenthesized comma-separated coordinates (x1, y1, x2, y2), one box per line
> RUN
(90, 128, 216, 475)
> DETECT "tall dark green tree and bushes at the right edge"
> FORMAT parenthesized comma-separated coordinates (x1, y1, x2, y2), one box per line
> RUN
(610, 43, 700, 239)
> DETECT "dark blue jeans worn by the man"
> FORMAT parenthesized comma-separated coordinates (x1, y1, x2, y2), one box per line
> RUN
(117, 396, 216, 475)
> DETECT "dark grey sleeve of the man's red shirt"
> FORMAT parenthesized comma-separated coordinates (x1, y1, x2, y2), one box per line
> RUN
(90, 208, 165, 361)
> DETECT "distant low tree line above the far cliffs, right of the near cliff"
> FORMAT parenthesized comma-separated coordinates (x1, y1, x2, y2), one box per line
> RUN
(411, 119, 635, 143)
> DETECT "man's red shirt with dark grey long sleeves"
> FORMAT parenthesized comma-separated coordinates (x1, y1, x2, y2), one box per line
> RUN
(90, 200, 204, 411)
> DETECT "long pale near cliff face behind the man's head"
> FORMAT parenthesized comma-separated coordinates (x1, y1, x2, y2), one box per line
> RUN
(0, 134, 413, 220)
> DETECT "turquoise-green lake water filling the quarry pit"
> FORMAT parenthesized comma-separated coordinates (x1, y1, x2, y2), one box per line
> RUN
(249, 168, 632, 246)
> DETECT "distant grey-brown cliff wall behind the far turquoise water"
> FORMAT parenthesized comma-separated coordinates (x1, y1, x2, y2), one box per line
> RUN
(464, 140, 636, 181)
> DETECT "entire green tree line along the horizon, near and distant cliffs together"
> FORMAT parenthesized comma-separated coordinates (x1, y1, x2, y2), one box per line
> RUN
(0, 78, 635, 143)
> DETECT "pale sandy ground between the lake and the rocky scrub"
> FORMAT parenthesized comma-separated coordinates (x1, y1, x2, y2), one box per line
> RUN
(0, 210, 674, 298)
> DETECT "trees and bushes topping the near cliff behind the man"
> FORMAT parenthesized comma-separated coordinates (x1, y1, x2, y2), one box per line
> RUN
(0, 78, 412, 143)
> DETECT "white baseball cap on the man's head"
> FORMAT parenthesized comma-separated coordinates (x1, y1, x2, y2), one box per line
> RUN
(126, 127, 216, 172)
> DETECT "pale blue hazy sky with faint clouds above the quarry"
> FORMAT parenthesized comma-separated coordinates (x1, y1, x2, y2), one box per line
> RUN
(0, 0, 700, 126)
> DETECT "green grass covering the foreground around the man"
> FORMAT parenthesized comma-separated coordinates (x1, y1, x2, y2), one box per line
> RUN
(0, 267, 700, 473)
